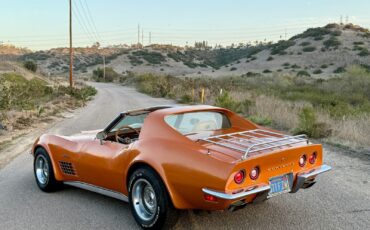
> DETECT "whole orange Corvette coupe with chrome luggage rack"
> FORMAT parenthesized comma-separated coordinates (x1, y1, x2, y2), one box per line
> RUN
(32, 106, 331, 229)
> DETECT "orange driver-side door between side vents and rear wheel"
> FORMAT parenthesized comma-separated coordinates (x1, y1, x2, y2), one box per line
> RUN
(76, 138, 129, 192)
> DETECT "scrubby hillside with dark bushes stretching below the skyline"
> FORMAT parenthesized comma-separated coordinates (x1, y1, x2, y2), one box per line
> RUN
(5, 24, 370, 77)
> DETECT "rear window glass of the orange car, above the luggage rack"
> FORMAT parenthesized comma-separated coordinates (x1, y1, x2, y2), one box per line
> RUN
(164, 111, 231, 135)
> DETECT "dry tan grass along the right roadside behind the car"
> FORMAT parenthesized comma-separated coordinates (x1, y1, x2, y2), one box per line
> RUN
(230, 92, 370, 148)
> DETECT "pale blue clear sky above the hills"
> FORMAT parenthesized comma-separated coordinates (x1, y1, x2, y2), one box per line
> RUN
(0, 0, 370, 50)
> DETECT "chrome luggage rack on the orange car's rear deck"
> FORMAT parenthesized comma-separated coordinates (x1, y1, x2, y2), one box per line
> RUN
(198, 129, 309, 160)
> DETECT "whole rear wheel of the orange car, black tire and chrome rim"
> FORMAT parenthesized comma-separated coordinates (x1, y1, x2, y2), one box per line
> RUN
(129, 167, 178, 229)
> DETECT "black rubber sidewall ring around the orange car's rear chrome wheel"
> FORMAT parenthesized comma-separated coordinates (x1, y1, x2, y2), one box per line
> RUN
(128, 168, 170, 229)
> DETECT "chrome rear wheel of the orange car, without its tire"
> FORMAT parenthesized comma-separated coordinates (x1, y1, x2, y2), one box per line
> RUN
(132, 179, 157, 221)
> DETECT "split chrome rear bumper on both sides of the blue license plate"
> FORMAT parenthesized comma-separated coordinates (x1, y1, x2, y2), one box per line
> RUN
(202, 165, 331, 200)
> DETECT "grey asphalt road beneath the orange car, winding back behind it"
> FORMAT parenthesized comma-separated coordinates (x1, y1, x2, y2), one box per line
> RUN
(0, 83, 370, 230)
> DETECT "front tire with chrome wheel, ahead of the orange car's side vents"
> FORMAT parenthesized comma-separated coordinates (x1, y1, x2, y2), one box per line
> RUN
(33, 148, 62, 192)
